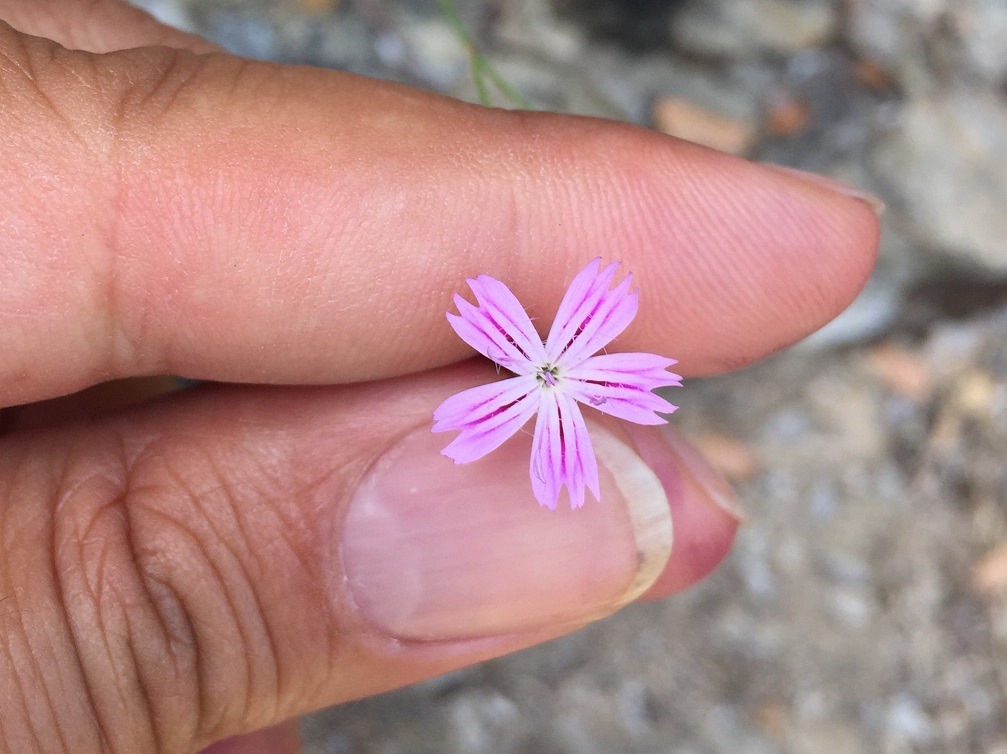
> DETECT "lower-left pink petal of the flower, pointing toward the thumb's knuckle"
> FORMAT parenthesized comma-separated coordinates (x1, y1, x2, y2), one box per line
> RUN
(433, 375, 539, 463)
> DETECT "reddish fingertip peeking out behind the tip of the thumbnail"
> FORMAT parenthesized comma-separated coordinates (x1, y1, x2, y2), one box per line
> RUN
(626, 425, 745, 595)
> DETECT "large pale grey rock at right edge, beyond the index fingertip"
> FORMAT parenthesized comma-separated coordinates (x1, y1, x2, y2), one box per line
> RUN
(874, 90, 1007, 278)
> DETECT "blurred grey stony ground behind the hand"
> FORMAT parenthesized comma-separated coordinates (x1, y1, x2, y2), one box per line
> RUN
(129, 0, 1007, 754)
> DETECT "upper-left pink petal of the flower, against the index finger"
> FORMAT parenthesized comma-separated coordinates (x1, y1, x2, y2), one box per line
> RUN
(447, 275, 546, 374)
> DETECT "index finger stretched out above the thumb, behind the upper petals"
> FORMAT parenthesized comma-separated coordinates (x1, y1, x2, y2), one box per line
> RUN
(0, 29, 878, 404)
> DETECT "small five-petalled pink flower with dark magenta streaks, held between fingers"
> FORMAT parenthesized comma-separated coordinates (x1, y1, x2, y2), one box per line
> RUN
(433, 259, 682, 509)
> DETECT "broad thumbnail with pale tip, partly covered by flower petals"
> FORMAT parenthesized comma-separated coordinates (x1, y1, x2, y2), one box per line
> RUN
(340, 426, 672, 640)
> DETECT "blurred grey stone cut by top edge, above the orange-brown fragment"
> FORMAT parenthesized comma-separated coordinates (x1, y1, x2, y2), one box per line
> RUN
(672, 0, 839, 58)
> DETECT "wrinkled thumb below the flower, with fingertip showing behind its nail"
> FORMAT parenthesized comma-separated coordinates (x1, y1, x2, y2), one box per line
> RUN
(0, 364, 737, 752)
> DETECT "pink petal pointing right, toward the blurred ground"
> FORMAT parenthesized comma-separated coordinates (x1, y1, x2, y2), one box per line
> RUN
(564, 353, 682, 424)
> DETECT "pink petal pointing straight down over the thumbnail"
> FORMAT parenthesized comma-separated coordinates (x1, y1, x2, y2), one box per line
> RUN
(531, 391, 601, 509)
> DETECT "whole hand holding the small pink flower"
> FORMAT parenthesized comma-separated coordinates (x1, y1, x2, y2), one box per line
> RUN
(0, 0, 878, 752)
